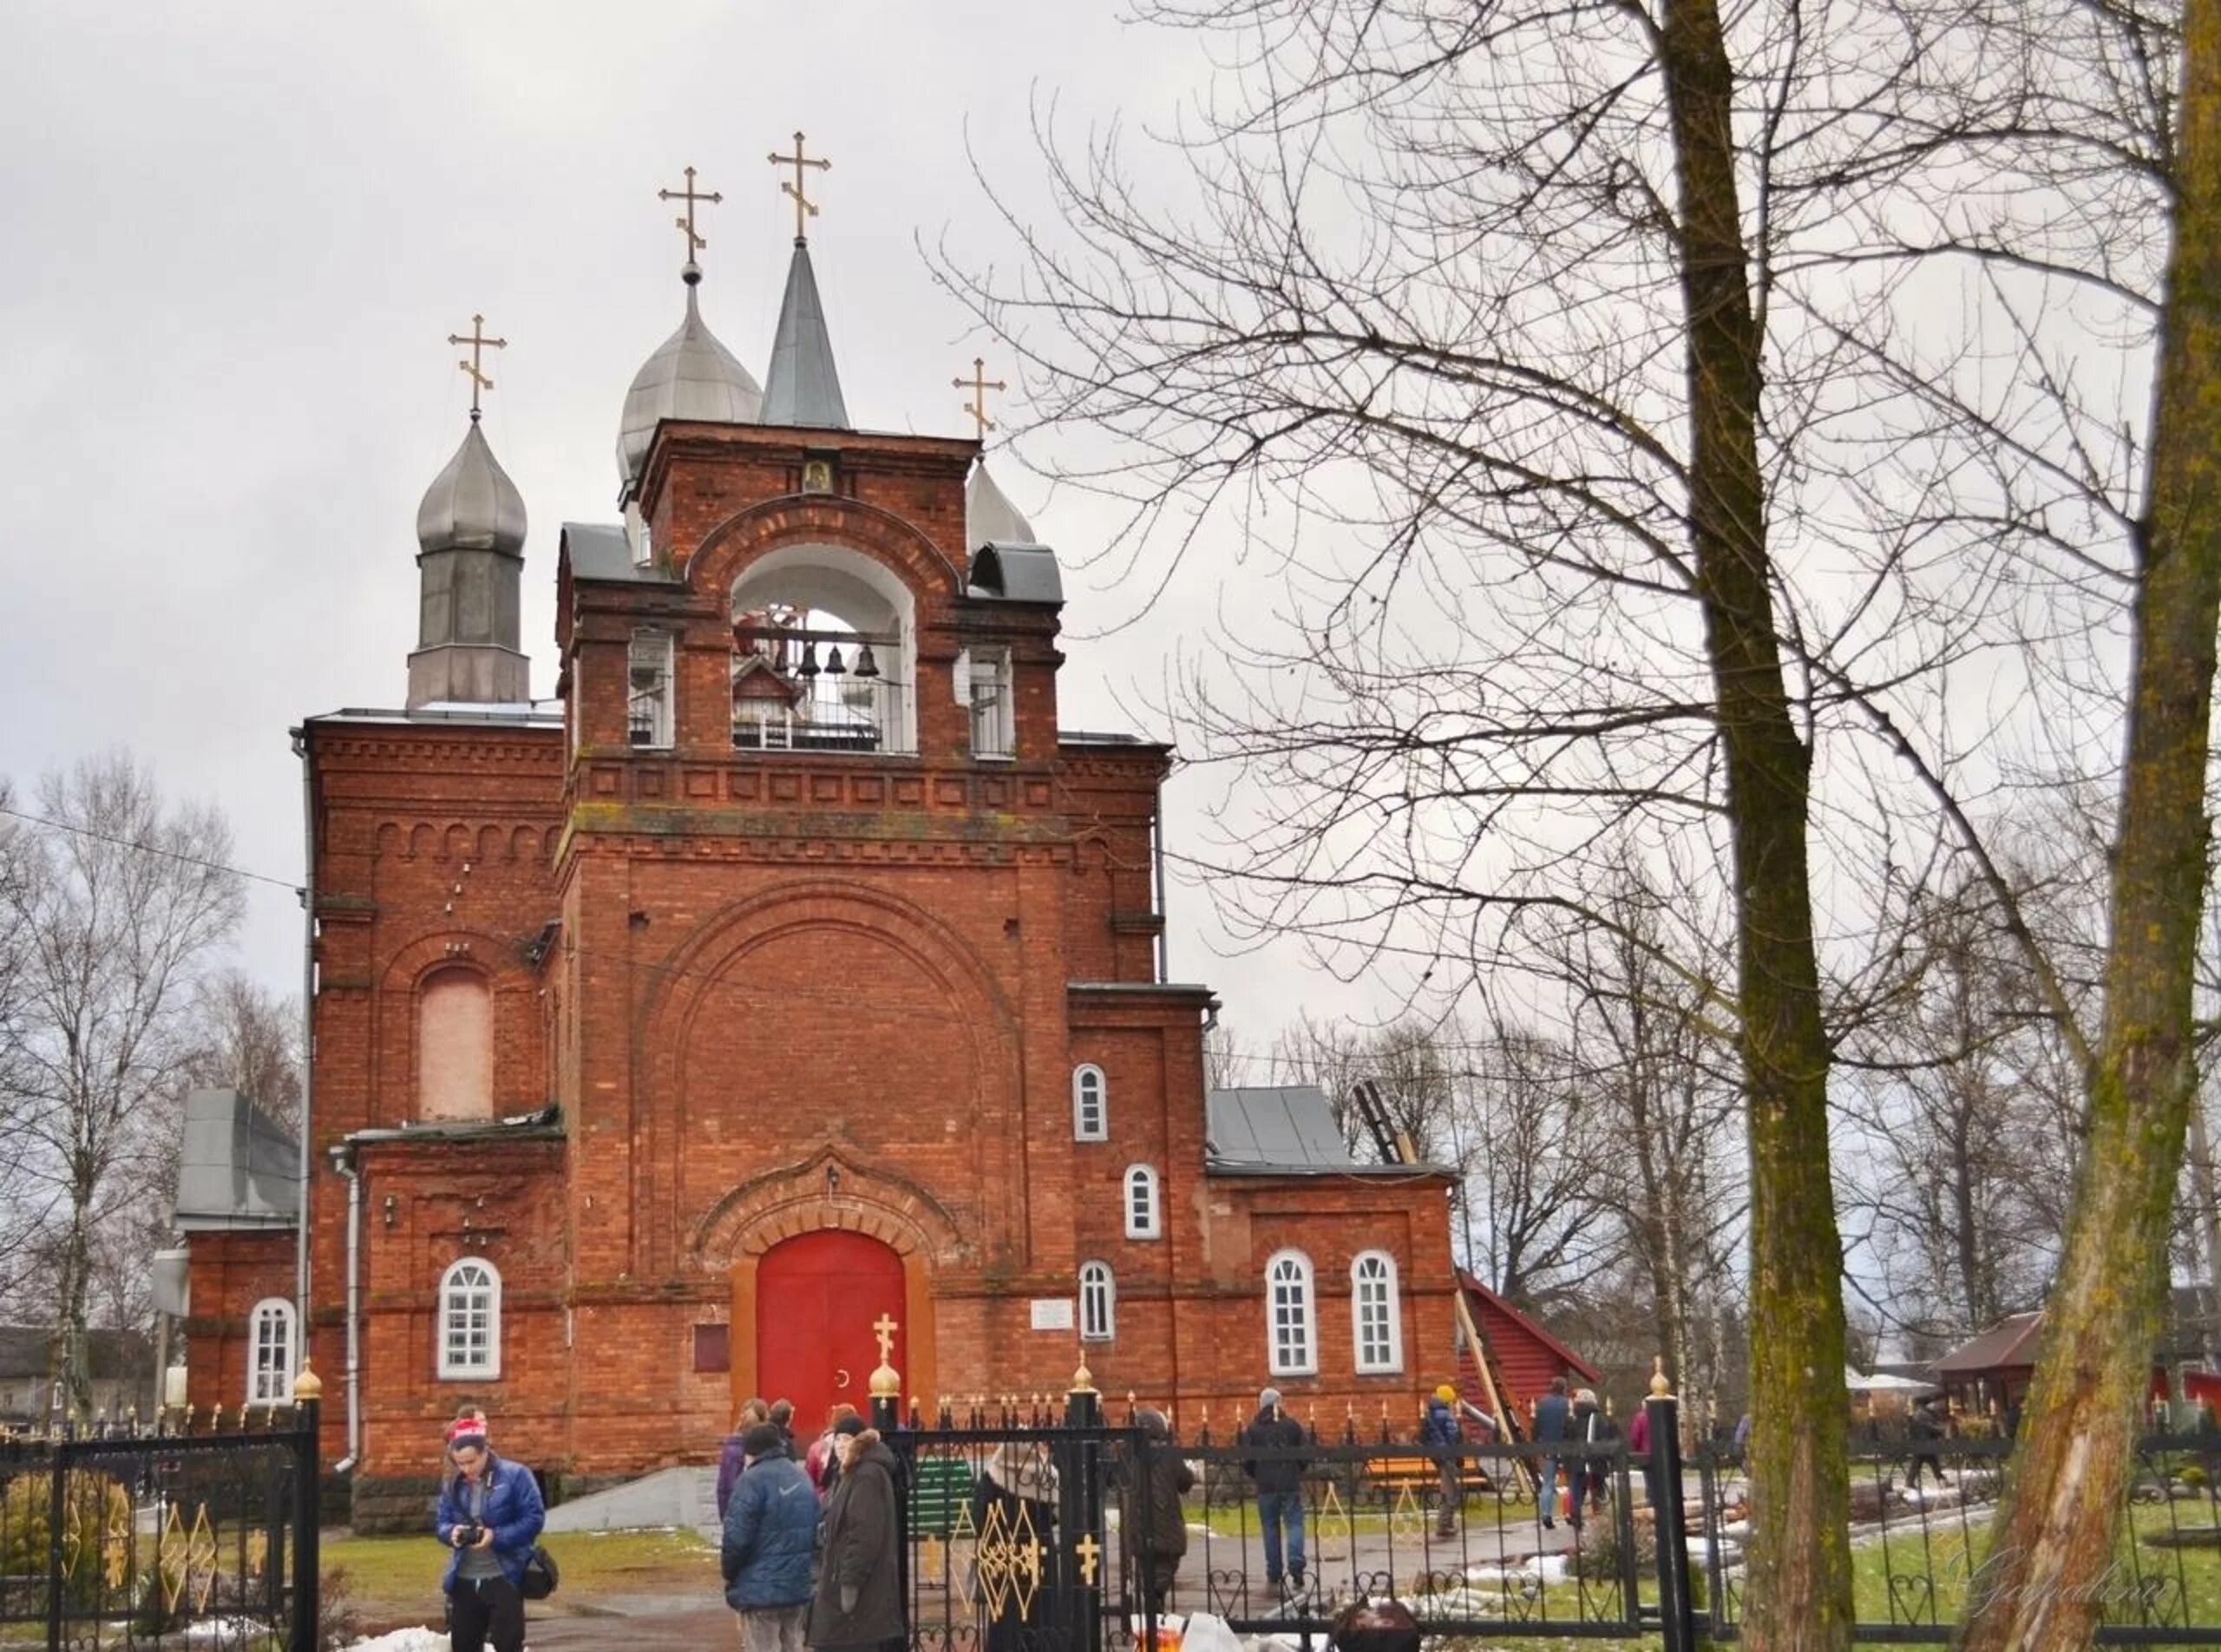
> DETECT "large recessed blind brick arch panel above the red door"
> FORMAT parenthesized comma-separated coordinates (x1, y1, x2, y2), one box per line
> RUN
(633, 879, 1024, 1272)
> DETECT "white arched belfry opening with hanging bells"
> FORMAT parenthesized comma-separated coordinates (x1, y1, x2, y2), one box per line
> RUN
(733, 544, 917, 755)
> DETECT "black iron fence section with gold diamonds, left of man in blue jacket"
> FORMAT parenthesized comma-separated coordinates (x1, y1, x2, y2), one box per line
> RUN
(0, 1399, 318, 1652)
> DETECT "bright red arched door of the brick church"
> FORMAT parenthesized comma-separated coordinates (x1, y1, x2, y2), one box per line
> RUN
(755, 1228, 904, 1439)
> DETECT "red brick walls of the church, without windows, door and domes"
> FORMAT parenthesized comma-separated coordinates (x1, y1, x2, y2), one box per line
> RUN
(189, 410, 1452, 1490)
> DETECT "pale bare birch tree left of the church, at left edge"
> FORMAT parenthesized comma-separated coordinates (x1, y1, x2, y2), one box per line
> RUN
(0, 753, 239, 1414)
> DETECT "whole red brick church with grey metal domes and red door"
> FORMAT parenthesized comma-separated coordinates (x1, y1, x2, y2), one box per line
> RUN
(180, 161, 1455, 1497)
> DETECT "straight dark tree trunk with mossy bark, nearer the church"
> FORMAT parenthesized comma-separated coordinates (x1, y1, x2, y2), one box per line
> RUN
(1659, 0, 1850, 1652)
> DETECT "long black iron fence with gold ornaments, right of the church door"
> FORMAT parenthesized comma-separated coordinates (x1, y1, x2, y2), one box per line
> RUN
(881, 1393, 2221, 1652)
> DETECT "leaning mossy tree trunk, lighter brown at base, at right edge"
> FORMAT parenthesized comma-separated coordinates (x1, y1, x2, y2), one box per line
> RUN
(1963, 0, 2221, 1652)
